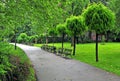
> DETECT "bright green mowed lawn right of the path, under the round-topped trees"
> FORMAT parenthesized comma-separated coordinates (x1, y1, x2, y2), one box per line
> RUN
(34, 43, 120, 75)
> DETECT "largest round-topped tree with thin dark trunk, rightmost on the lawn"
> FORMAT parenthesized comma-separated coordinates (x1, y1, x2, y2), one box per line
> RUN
(82, 3, 115, 62)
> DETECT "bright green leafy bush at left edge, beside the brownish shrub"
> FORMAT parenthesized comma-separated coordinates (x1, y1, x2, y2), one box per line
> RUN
(0, 42, 13, 76)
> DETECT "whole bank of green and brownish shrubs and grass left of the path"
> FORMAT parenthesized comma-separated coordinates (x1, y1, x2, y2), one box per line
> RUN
(0, 42, 36, 81)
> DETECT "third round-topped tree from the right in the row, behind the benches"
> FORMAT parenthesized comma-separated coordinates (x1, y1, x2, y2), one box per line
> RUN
(57, 24, 66, 52)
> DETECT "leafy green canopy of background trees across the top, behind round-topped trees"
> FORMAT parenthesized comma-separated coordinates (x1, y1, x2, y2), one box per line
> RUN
(0, 0, 119, 43)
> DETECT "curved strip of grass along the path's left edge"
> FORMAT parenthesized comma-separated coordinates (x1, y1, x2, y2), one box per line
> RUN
(11, 46, 36, 81)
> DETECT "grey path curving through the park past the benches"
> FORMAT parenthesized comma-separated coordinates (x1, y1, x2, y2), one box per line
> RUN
(15, 44, 120, 81)
